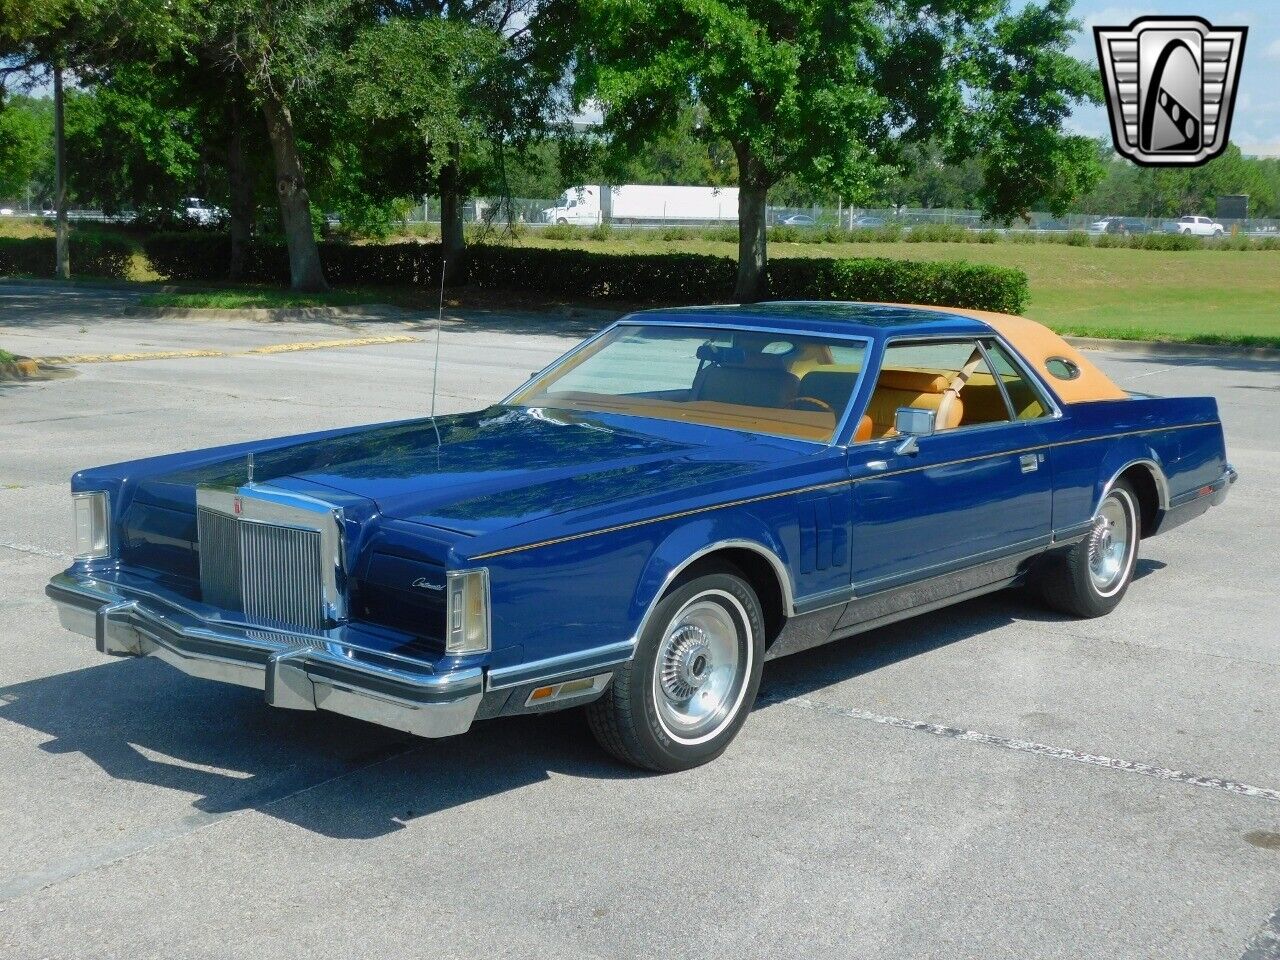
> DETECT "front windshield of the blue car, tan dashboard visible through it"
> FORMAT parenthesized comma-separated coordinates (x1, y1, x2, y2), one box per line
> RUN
(512, 324, 867, 443)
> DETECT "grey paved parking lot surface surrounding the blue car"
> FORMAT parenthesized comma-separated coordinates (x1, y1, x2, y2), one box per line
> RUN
(0, 285, 1280, 960)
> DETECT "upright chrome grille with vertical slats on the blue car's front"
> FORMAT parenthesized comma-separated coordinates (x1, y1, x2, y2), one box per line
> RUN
(196, 498, 326, 631)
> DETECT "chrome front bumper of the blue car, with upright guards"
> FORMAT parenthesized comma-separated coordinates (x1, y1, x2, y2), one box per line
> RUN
(45, 573, 484, 737)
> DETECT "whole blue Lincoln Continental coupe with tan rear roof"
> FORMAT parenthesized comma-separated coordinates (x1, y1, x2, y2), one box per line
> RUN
(47, 303, 1235, 771)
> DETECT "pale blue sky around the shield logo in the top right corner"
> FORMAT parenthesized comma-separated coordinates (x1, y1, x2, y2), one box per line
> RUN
(1070, 0, 1280, 156)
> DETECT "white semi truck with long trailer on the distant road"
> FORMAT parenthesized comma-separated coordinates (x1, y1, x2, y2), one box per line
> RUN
(543, 183, 737, 227)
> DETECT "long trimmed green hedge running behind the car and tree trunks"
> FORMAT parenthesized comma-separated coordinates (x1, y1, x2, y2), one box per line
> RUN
(143, 233, 1028, 314)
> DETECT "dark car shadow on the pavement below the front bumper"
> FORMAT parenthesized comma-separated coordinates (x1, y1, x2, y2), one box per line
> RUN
(0, 659, 637, 840)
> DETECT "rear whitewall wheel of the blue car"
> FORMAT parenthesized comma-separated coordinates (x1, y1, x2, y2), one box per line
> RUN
(1041, 480, 1142, 617)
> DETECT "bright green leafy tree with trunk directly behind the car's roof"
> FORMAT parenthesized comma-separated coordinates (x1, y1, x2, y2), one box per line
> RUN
(578, 0, 1100, 300)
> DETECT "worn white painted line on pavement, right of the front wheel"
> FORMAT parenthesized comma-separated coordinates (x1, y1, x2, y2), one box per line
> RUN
(763, 696, 1280, 803)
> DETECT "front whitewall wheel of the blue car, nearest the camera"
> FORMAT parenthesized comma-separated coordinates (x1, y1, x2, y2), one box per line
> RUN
(586, 568, 764, 773)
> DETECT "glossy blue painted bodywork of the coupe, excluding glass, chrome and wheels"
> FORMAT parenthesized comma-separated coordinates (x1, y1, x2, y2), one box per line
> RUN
(64, 303, 1226, 669)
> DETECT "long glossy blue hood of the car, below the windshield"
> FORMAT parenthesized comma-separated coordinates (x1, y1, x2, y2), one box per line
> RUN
(129, 406, 815, 536)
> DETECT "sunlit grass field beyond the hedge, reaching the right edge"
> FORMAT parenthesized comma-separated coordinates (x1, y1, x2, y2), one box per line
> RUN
(496, 232, 1280, 347)
